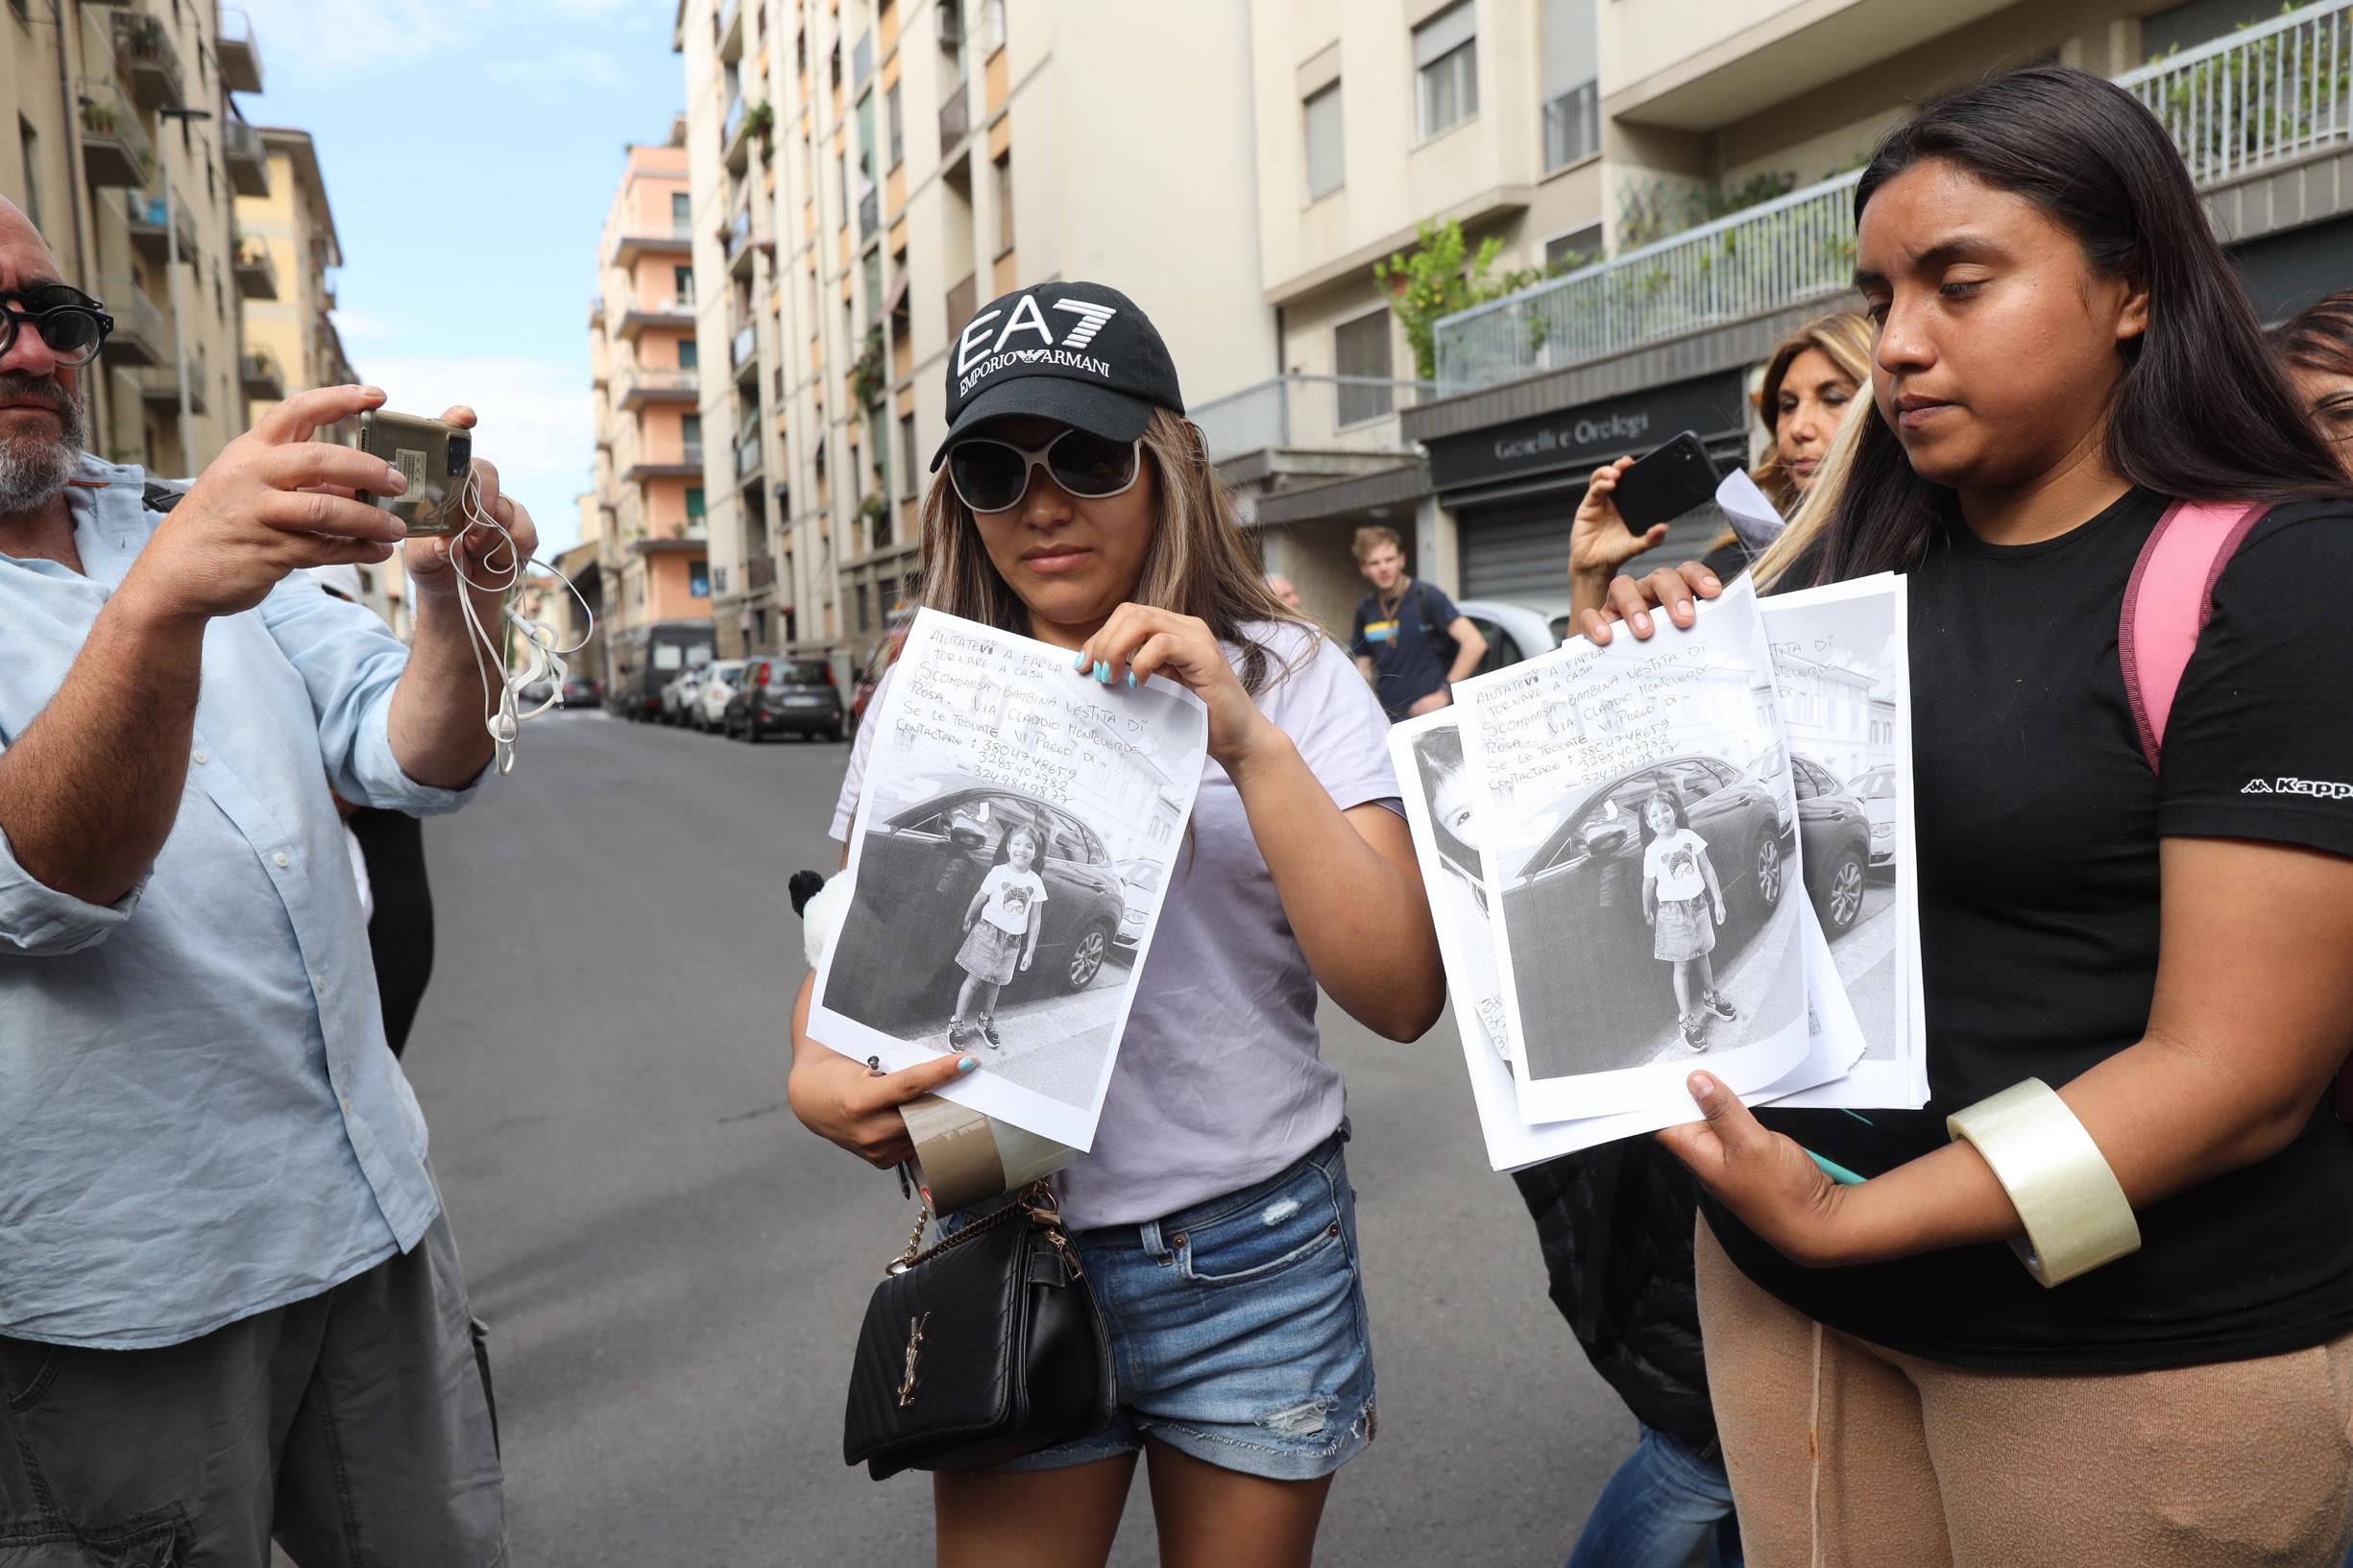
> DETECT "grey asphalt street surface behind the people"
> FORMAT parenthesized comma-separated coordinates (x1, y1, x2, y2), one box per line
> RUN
(407, 712, 1636, 1568)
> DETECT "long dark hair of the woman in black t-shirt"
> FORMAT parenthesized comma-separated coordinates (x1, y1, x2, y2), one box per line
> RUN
(1821, 66, 2348, 581)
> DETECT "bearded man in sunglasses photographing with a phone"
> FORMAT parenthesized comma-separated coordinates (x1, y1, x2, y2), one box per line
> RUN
(0, 200, 510, 1568)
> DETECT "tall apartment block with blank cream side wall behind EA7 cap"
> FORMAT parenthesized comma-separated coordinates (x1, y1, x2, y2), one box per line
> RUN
(678, 0, 1277, 680)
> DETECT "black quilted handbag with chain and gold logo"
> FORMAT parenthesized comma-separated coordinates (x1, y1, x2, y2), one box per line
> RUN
(842, 1182, 1118, 1481)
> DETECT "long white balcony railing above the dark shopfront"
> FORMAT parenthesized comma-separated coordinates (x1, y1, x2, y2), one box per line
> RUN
(1436, 0, 2353, 395)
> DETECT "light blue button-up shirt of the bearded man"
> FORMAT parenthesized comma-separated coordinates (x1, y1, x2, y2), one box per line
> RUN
(0, 458, 473, 1349)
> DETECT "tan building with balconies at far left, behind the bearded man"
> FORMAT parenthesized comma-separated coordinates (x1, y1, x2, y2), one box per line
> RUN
(0, 0, 268, 475)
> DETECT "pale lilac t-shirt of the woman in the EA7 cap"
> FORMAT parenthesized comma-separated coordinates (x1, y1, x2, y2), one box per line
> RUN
(833, 623, 1400, 1229)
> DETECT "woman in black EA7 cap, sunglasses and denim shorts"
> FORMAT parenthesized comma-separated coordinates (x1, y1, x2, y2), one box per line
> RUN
(790, 282, 1444, 1568)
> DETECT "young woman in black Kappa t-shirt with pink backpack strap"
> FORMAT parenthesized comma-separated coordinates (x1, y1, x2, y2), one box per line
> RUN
(1584, 68, 2353, 1568)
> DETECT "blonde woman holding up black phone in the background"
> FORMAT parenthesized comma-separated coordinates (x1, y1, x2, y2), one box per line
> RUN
(1569, 310, 1871, 612)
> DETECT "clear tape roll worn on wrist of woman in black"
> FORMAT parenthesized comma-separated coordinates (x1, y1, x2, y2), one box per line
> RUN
(1944, 1079, 2142, 1286)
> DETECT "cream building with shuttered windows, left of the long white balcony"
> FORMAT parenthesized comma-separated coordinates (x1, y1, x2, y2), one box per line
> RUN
(1201, 0, 1605, 637)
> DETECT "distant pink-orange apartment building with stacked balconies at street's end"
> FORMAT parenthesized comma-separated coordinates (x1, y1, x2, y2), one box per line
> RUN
(586, 120, 711, 700)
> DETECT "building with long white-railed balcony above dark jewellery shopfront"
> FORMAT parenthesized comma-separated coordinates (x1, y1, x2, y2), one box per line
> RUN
(1402, 0, 2353, 597)
